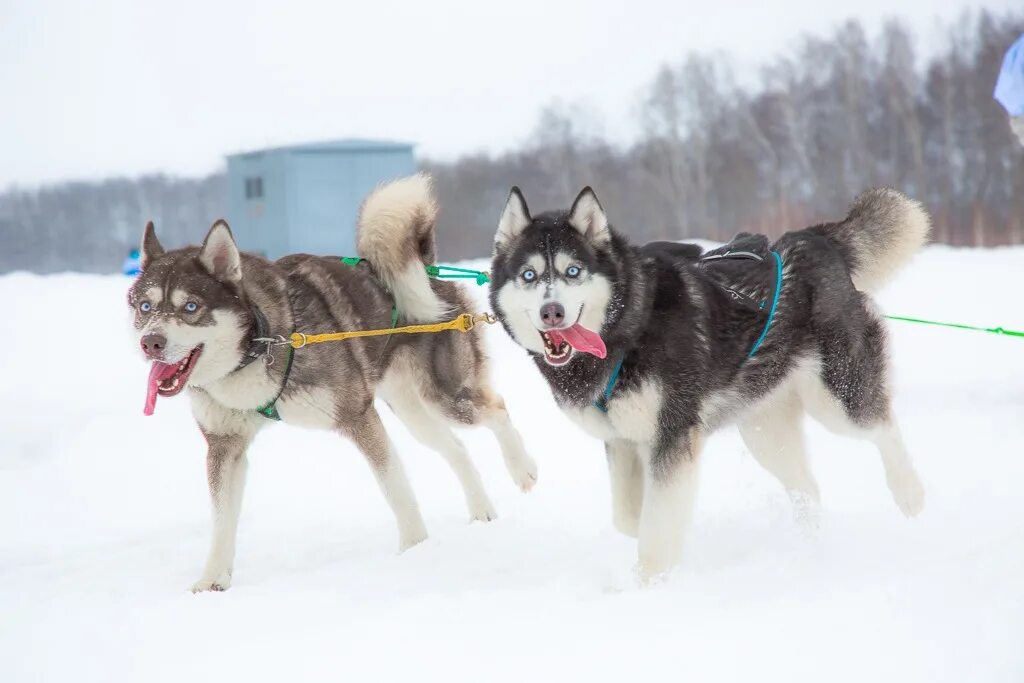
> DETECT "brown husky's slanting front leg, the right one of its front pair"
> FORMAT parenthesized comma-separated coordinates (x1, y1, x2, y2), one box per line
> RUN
(341, 405, 427, 552)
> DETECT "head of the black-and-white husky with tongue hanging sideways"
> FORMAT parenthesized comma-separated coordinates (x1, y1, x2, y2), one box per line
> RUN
(490, 187, 614, 367)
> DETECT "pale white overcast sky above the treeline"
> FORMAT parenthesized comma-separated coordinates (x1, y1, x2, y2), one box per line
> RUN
(0, 0, 1020, 188)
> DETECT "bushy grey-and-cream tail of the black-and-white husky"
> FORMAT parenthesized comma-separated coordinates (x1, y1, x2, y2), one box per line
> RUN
(823, 187, 932, 292)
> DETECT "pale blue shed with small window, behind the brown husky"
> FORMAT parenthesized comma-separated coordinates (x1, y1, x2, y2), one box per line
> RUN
(227, 139, 416, 259)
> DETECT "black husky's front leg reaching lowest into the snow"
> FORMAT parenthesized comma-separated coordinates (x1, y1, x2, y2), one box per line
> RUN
(637, 430, 701, 583)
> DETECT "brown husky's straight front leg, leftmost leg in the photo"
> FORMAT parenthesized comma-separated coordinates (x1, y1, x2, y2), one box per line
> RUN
(191, 434, 251, 593)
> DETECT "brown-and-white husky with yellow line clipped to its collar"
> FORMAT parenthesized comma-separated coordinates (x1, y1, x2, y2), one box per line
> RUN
(128, 175, 537, 591)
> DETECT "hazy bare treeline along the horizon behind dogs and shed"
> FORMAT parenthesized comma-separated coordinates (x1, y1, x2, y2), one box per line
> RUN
(0, 11, 1024, 271)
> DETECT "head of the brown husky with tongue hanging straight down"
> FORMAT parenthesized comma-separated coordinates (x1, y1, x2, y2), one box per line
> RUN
(128, 220, 253, 415)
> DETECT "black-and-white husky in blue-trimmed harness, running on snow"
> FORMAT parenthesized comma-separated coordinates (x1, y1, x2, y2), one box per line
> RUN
(490, 187, 930, 579)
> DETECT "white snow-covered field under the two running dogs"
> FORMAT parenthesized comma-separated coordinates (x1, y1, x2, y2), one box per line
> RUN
(0, 247, 1024, 683)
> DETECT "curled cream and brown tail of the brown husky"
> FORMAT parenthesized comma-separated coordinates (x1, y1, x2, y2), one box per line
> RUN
(356, 173, 451, 323)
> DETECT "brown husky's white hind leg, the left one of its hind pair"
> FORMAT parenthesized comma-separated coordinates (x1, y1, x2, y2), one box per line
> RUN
(387, 392, 498, 521)
